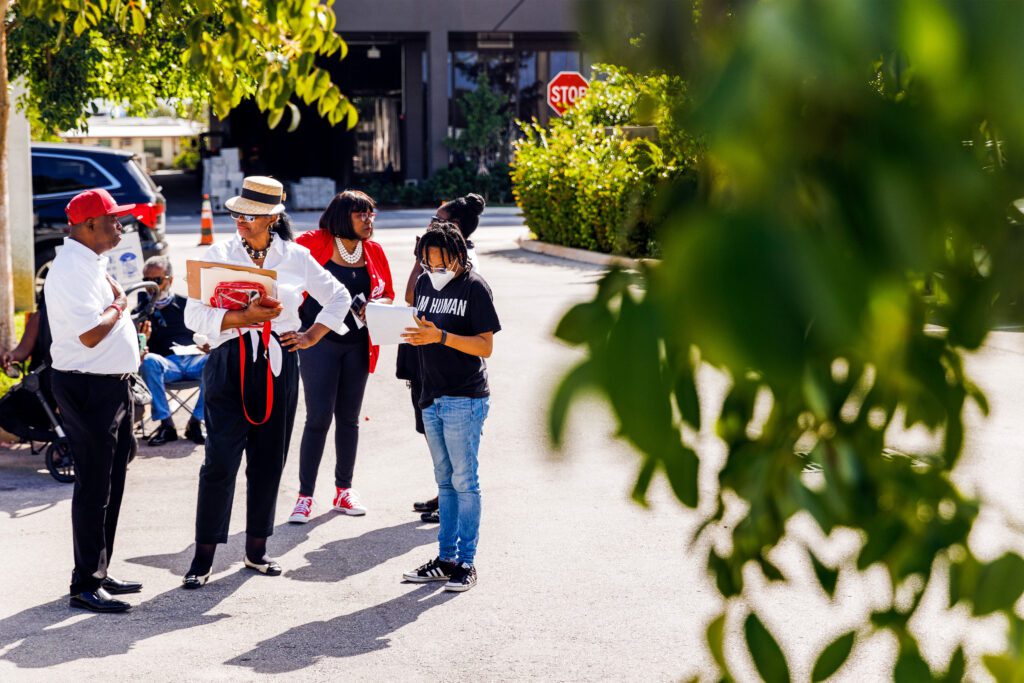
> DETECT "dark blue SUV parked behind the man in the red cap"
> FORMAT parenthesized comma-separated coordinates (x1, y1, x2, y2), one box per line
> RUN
(32, 142, 167, 288)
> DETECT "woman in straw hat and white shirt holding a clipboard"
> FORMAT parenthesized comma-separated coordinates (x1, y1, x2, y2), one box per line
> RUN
(183, 176, 351, 589)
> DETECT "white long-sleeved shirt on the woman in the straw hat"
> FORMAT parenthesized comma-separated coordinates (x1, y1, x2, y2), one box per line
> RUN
(185, 236, 352, 348)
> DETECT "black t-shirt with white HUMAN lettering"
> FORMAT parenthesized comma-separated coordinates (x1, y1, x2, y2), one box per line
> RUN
(414, 270, 502, 408)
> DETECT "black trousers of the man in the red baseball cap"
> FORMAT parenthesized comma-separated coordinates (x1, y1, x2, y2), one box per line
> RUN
(53, 371, 135, 595)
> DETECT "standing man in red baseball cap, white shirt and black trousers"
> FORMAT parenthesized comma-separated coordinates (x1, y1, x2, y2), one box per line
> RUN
(43, 189, 142, 612)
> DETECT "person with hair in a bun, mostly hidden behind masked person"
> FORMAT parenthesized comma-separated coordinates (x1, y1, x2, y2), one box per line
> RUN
(397, 193, 486, 523)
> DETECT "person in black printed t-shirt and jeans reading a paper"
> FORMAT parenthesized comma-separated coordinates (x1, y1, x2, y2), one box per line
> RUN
(402, 221, 502, 592)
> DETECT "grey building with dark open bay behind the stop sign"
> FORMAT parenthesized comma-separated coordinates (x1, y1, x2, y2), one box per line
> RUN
(212, 0, 589, 184)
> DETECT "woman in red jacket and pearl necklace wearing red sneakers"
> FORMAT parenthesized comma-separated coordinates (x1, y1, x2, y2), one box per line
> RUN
(288, 189, 394, 523)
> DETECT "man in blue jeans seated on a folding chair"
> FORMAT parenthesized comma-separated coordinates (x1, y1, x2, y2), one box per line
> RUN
(139, 256, 209, 445)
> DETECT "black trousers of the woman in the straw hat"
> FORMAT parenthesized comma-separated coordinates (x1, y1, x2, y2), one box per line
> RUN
(196, 334, 299, 543)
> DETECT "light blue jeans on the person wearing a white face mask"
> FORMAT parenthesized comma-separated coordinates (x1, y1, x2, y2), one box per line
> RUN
(423, 396, 490, 564)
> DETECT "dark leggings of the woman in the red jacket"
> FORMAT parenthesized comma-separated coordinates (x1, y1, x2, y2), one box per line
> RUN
(299, 339, 370, 496)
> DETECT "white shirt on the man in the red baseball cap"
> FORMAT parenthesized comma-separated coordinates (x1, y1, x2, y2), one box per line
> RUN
(43, 238, 139, 375)
